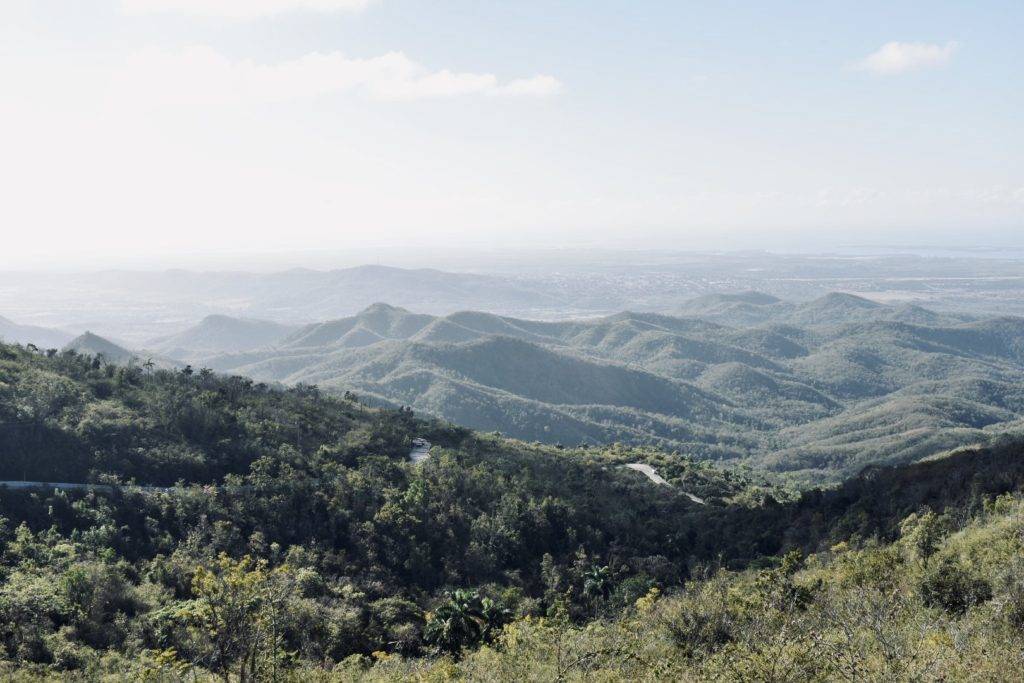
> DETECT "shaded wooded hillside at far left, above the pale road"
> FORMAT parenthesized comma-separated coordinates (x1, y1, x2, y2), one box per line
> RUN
(0, 339, 423, 484)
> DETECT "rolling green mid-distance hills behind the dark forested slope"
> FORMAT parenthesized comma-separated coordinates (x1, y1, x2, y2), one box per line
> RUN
(188, 294, 1024, 484)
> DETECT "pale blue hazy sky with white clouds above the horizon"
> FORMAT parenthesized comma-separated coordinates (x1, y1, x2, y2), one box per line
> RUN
(0, 0, 1024, 268)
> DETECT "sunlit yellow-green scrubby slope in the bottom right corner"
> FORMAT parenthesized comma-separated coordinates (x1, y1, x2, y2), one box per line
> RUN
(362, 496, 1024, 682)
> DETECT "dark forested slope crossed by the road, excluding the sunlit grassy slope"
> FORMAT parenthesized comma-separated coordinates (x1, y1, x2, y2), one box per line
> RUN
(0, 346, 1024, 680)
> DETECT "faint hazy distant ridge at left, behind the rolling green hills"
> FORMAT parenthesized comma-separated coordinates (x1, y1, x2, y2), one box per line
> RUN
(0, 265, 569, 350)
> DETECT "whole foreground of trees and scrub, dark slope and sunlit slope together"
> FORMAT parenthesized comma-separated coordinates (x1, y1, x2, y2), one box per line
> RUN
(0, 346, 1024, 680)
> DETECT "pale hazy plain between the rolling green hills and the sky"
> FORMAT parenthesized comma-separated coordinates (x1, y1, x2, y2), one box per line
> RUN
(0, 248, 1024, 346)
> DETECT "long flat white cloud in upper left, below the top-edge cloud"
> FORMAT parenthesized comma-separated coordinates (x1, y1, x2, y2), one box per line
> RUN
(117, 46, 561, 104)
